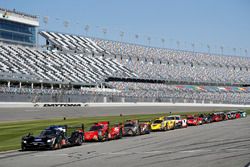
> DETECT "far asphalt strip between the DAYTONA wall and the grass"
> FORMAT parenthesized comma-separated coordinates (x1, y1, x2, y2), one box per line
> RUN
(0, 106, 242, 121)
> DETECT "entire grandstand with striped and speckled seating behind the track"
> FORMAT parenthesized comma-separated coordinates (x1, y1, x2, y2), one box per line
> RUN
(0, 9, 250, 104)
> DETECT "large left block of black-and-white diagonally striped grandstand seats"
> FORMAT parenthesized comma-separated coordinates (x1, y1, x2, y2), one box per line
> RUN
(0, 45, 136, 84)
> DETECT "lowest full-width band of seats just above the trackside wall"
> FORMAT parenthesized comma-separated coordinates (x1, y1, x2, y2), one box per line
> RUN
(0, 82, 250, 104)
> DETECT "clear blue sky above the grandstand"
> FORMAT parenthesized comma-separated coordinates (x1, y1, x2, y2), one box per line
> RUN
(0, 0, 250, 56)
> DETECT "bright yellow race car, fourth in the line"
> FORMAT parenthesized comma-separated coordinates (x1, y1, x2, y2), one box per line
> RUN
(151, 116, 175, 131)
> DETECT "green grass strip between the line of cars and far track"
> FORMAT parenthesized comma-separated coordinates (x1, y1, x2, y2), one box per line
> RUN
(0, 109, 250, 151)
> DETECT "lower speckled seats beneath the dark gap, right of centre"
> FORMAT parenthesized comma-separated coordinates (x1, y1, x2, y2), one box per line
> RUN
(110, 82, 250, 104)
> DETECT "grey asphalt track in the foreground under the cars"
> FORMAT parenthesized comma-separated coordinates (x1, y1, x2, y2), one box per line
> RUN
(0, 117, 250, 167)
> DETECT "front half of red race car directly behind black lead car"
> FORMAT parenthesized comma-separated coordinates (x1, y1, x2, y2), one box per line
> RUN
(84, 121, 111, 141)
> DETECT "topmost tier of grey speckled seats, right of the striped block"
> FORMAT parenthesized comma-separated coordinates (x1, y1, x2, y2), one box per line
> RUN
(92, 38, 250, 68)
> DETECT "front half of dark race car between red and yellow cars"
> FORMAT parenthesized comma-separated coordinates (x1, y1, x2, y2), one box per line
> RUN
(124, 120, 141, 136)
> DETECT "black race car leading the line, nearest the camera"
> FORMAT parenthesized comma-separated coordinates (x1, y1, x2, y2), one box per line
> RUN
(21, 124, 84, 151)
